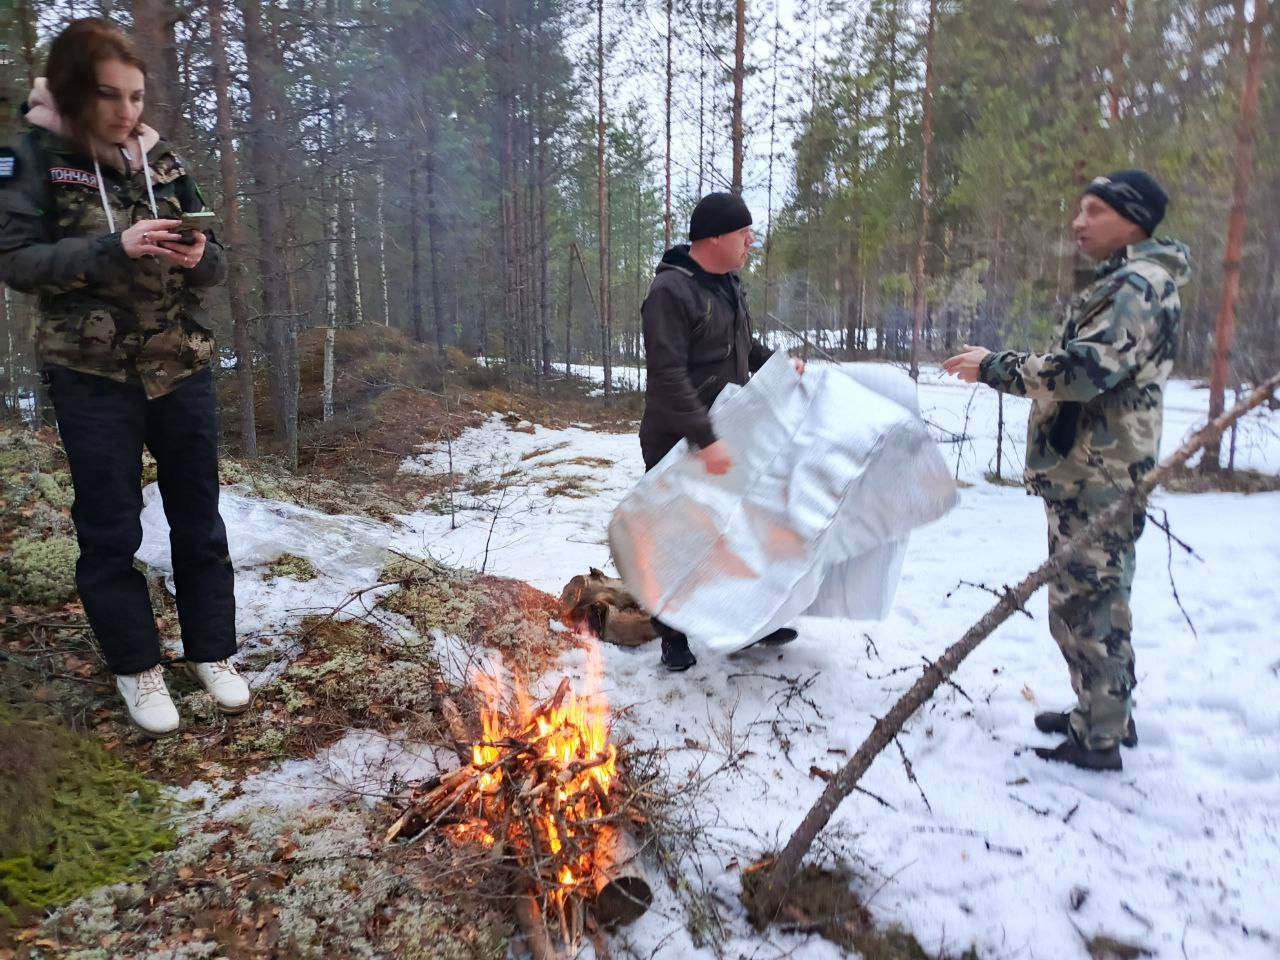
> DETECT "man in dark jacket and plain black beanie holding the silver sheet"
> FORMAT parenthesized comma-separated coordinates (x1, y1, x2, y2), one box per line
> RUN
(640, 193, 804, 671)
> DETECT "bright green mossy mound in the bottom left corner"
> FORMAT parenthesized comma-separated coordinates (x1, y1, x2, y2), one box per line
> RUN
(0, 707, 173, 923)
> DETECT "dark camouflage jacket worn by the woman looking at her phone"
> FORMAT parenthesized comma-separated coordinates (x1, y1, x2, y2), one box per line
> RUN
(0, 127, 227, 398)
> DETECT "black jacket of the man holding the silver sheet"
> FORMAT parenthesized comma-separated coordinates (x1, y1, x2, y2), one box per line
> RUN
(640, 243, 773, 467)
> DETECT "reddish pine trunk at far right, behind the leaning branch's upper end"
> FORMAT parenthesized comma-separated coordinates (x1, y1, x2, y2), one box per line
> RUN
(1201, 0, 1271, 471)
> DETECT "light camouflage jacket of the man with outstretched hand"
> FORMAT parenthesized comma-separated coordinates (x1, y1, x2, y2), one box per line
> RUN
(979, 239, 1190, 503)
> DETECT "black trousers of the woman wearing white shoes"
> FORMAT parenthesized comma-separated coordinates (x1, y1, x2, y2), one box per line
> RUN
(46, 367, 236, 673)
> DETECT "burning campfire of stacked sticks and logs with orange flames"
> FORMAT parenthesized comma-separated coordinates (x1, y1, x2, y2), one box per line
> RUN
(387, 664, 653, 956)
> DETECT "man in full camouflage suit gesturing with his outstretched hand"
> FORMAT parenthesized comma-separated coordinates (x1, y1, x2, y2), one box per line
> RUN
(943, 170, 1189, 769)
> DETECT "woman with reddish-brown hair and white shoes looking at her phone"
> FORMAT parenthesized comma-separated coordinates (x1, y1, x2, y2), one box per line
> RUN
(0, 18, 250, 736)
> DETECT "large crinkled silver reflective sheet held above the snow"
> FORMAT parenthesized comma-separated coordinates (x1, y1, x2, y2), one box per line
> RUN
(609, 352, 956, 653)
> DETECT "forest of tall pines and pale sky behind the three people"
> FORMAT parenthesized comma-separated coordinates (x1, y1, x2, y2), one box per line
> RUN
(0, 0, 1280, 465)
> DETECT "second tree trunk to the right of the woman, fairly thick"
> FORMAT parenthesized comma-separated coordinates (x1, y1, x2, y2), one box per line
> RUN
(239, 0, 298, 466)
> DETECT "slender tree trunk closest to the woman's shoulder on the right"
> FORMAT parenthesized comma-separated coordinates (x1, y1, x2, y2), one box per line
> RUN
(209, 0, 257, 460)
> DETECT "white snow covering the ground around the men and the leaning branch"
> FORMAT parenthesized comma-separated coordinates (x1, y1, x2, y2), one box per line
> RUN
(143, 370, 1280, 960)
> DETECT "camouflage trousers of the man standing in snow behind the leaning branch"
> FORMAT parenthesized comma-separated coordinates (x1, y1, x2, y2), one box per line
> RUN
(1044, 499, 1146, 750)
